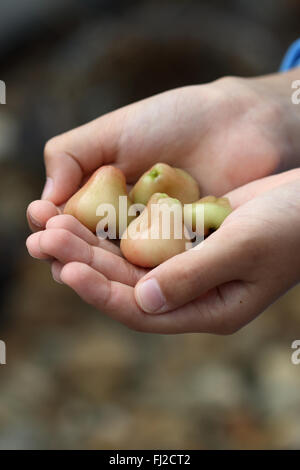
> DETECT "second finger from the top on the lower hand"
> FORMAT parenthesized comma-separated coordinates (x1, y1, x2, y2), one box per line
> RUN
(39, 229, 146, 285)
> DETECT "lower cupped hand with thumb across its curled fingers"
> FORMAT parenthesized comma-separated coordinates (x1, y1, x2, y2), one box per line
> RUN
(27, 169, 300, 334)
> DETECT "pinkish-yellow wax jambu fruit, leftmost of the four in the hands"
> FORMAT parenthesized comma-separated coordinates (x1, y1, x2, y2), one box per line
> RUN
(64, 165, 132, 236)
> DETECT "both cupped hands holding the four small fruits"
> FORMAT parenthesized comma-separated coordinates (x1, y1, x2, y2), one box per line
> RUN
(28, 72, 300, 333)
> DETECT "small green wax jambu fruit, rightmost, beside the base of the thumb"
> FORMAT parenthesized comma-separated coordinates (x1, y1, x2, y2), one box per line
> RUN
(184, 196, 232, 235)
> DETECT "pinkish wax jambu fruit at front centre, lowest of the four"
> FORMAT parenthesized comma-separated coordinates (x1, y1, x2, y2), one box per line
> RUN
(121, 194, 188, 268)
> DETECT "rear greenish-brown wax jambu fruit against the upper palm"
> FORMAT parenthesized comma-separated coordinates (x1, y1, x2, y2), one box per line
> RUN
(129, 163, 200, 205)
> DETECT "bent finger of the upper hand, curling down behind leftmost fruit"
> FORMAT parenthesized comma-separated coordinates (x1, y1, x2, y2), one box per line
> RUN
(42, 110, 123, 205)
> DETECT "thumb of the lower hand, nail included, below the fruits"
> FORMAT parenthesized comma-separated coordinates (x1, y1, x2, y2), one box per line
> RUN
(135, 227, 250, 313)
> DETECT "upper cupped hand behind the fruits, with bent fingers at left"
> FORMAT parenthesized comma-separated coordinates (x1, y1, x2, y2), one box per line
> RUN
(27, 69, 300, 231)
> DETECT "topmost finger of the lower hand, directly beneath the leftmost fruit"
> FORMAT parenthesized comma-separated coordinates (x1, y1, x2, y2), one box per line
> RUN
(46, 214, 121, 256)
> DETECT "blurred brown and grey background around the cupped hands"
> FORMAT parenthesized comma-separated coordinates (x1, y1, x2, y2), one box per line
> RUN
(0, 0, 300, 449)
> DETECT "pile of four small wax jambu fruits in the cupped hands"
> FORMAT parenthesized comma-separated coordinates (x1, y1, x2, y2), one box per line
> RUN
(64, 163, 232, 268)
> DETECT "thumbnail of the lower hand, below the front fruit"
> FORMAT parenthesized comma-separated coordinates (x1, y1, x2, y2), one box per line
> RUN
(136, 279, 166, 313)
